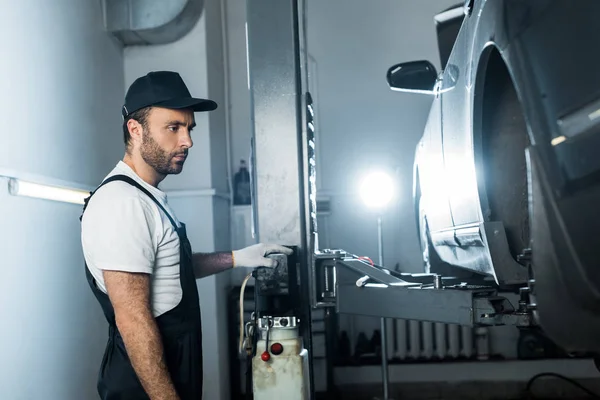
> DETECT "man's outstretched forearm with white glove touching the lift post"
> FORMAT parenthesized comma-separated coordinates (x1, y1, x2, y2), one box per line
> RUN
(192, 243, 292, 279)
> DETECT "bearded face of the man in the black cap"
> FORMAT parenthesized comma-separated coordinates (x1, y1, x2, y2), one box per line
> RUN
(140, 107, 196, 175)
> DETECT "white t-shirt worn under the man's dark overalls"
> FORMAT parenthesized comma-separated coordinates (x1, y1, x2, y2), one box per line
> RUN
(81, 161, 182, 317)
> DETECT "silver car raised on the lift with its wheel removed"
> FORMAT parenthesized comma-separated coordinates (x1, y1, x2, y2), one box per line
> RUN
(387, 0, 600, 354)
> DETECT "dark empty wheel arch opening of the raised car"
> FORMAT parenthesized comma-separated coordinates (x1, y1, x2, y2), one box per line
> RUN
(472, 43, 530, 257)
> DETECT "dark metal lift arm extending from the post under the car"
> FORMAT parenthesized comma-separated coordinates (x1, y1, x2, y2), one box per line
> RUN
(315, 250, 535, 327)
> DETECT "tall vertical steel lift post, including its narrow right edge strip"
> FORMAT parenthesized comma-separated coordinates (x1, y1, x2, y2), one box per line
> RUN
(246, 0, 316, 399)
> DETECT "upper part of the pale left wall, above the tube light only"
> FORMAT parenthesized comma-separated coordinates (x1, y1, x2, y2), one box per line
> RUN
(0, 0, 123, 184)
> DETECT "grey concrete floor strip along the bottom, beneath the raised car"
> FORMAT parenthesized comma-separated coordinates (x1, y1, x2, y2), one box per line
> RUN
(325, 359, 600, 400)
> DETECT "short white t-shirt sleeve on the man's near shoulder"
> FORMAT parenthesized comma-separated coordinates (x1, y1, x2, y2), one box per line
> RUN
(81, 187, 158, 274)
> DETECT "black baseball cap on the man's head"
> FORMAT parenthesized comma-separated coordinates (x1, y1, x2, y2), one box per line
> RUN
(121, 71, 217, 118)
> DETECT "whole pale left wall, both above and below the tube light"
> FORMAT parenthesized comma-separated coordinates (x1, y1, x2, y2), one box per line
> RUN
(0, 0, 123, 400)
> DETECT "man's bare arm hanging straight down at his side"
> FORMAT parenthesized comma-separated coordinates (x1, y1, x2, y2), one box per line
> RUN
(103, 271, 179, 400)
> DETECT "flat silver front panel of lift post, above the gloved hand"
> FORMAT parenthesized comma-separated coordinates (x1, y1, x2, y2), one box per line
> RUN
(246, 0, 304, 246)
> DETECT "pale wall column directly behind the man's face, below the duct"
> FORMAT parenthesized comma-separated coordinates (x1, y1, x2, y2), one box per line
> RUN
(124, 0, 230, 400)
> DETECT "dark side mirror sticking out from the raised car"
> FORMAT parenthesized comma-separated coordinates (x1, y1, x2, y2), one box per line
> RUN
(387, 60, 437, 94)
